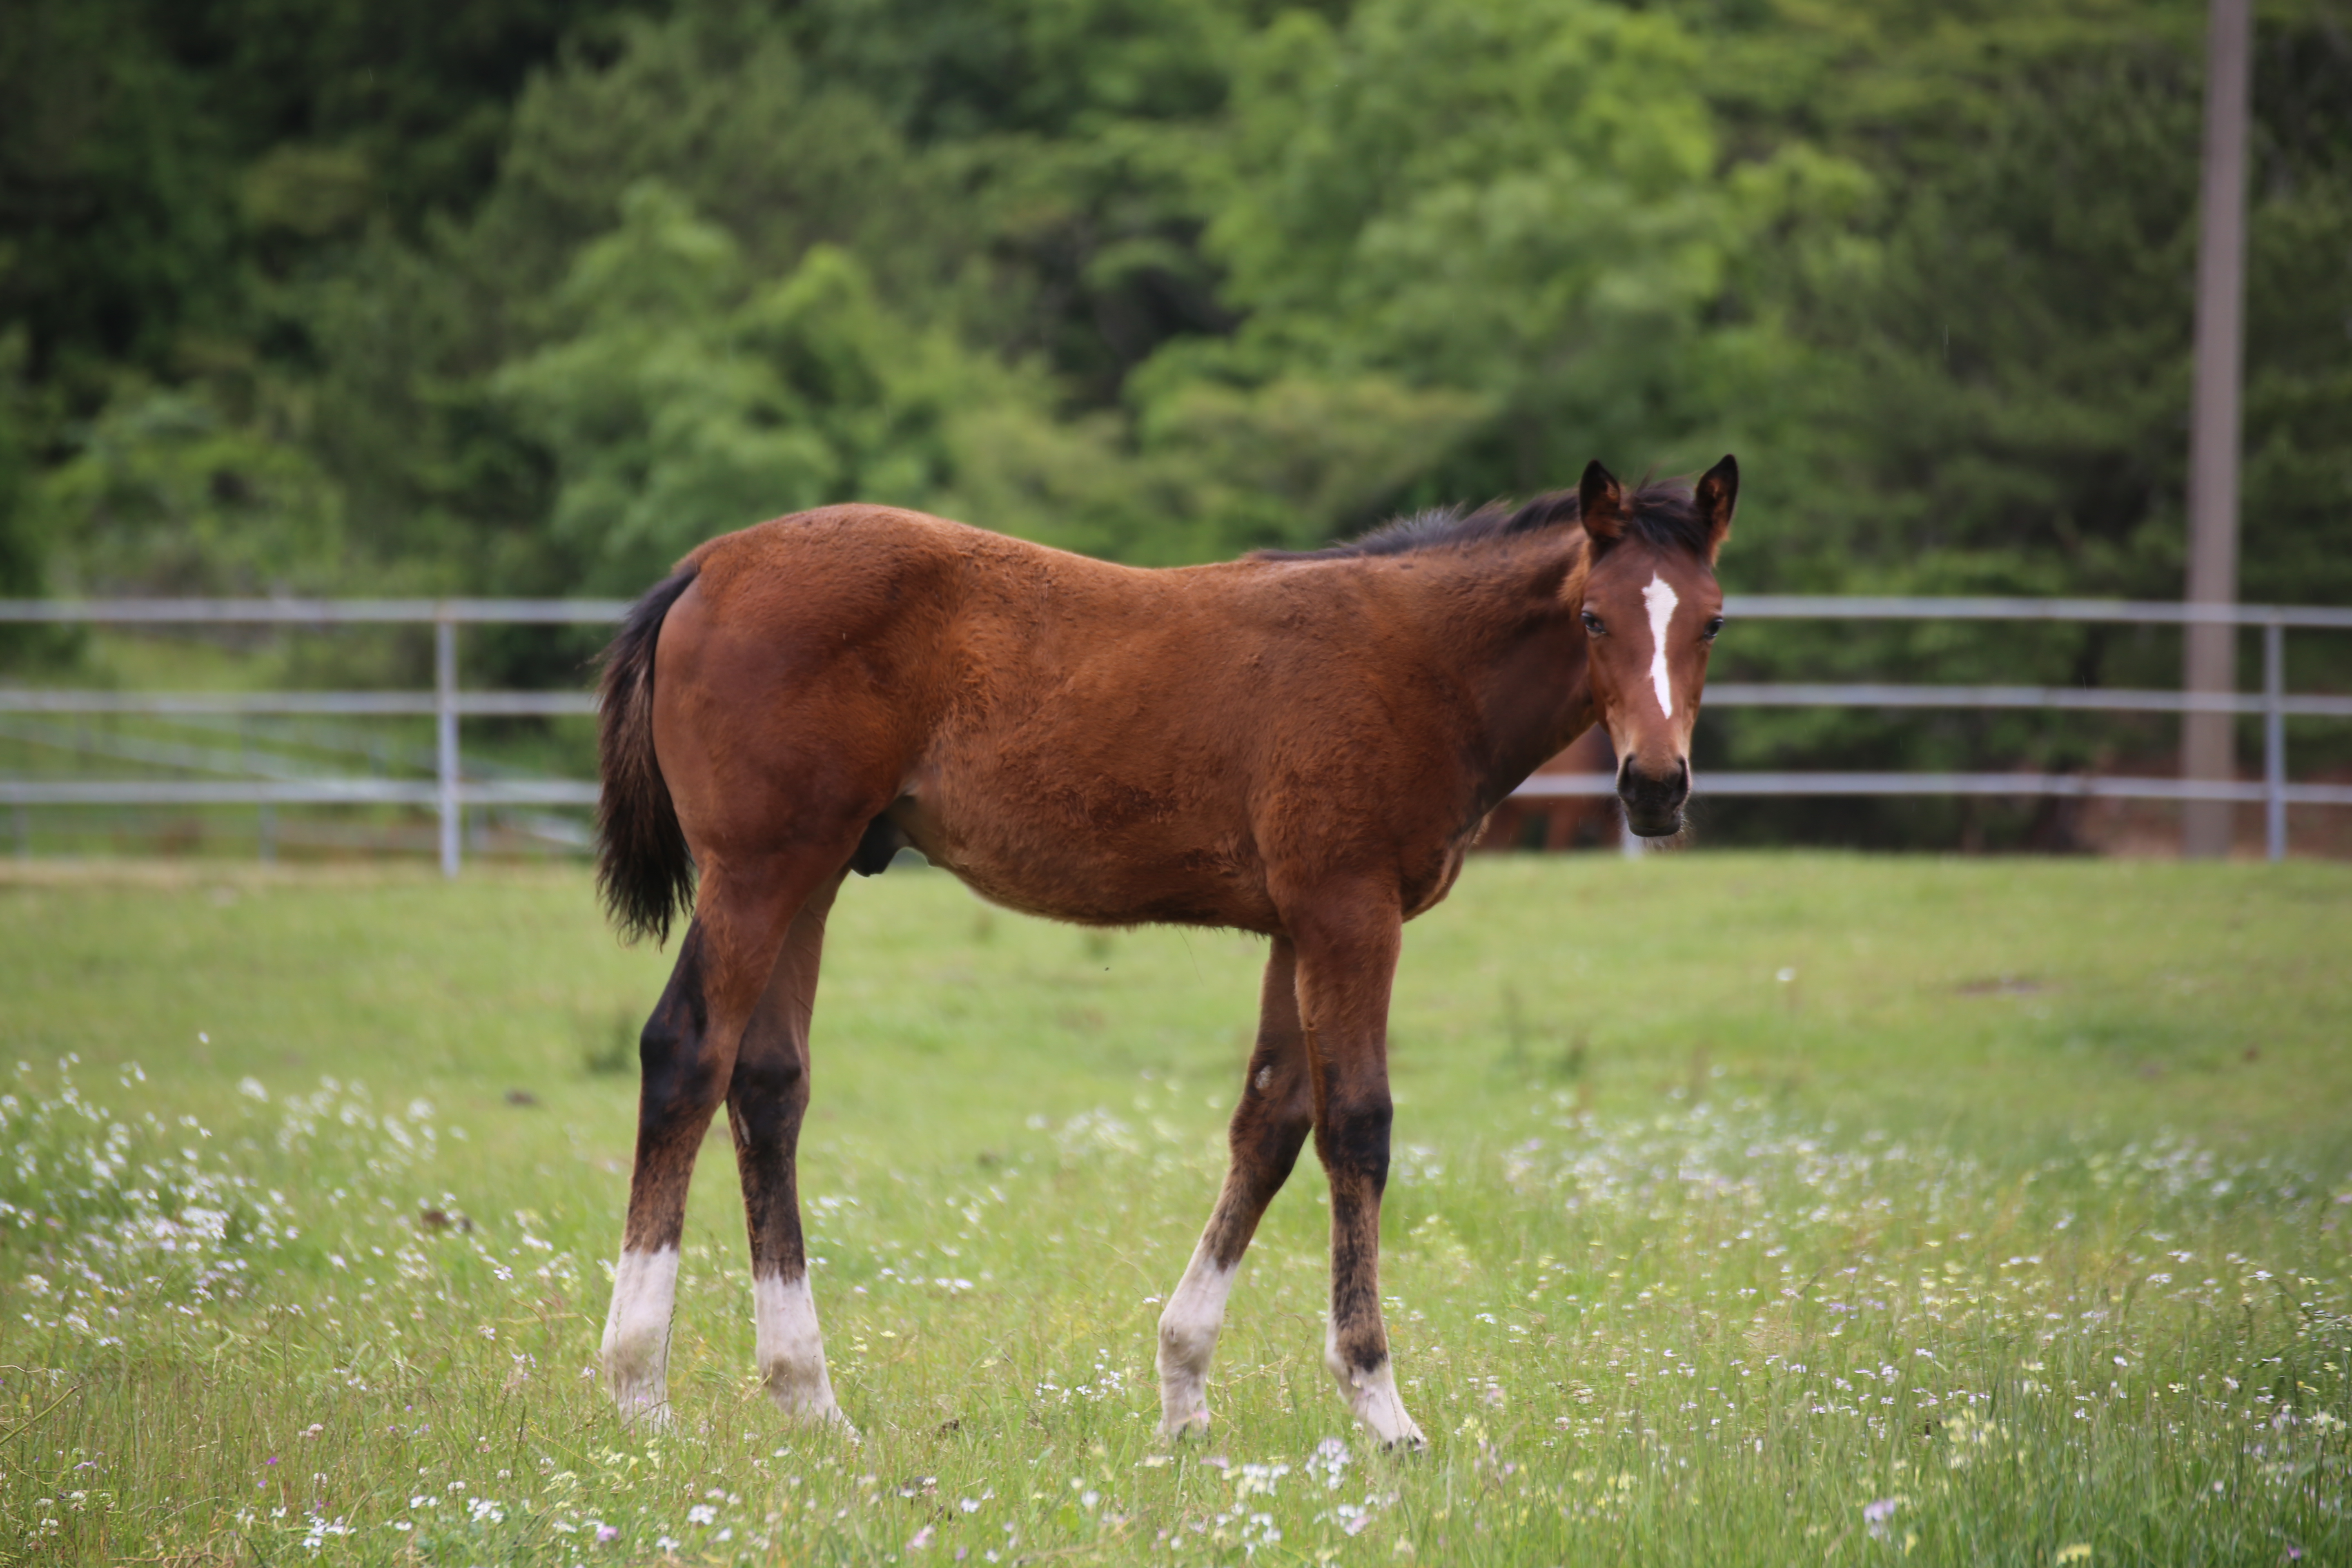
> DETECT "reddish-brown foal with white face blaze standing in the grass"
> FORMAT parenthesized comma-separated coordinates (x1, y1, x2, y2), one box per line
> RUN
(597, 459, 1738, 1443)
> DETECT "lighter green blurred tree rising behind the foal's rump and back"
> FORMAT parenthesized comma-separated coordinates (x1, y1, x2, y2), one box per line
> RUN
(494, 181, 1195, 592)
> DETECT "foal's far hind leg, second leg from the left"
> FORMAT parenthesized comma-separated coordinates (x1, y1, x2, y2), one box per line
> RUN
(727, 875, 849, 1427)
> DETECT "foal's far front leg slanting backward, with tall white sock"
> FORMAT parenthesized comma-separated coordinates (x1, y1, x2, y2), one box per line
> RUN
(1160, 935, 1315, 1437)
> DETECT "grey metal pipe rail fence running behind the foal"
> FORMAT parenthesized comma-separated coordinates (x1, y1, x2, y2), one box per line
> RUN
(0, 595, 2352, 877)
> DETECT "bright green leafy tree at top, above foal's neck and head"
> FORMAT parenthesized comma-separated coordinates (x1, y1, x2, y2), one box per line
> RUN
(1141, 0, 1825, 512)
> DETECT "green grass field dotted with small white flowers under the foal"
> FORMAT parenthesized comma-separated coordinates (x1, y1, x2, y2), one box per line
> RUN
(0, 853, 2352, 1566)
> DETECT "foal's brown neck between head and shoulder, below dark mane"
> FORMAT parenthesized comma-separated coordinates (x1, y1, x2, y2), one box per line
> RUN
(1435, 543, 1592, 806)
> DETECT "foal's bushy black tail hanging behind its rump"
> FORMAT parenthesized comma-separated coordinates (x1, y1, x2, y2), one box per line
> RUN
(595, 566, 696, 943)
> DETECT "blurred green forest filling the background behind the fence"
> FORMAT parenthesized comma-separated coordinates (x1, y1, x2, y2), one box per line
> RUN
(0, 0, 2352, 844)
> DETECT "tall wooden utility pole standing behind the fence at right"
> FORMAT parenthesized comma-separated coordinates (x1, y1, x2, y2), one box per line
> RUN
(2180, 0, 2253, 856)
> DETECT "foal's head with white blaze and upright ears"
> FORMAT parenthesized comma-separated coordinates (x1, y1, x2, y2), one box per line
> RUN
(1576, 456, 1740, 839)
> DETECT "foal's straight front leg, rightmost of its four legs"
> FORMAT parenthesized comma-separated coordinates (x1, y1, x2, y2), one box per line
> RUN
(1287, 891, 1423, 1448)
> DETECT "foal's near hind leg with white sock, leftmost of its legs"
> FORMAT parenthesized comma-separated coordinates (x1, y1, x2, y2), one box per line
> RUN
(602, 844, 849, 1422)
